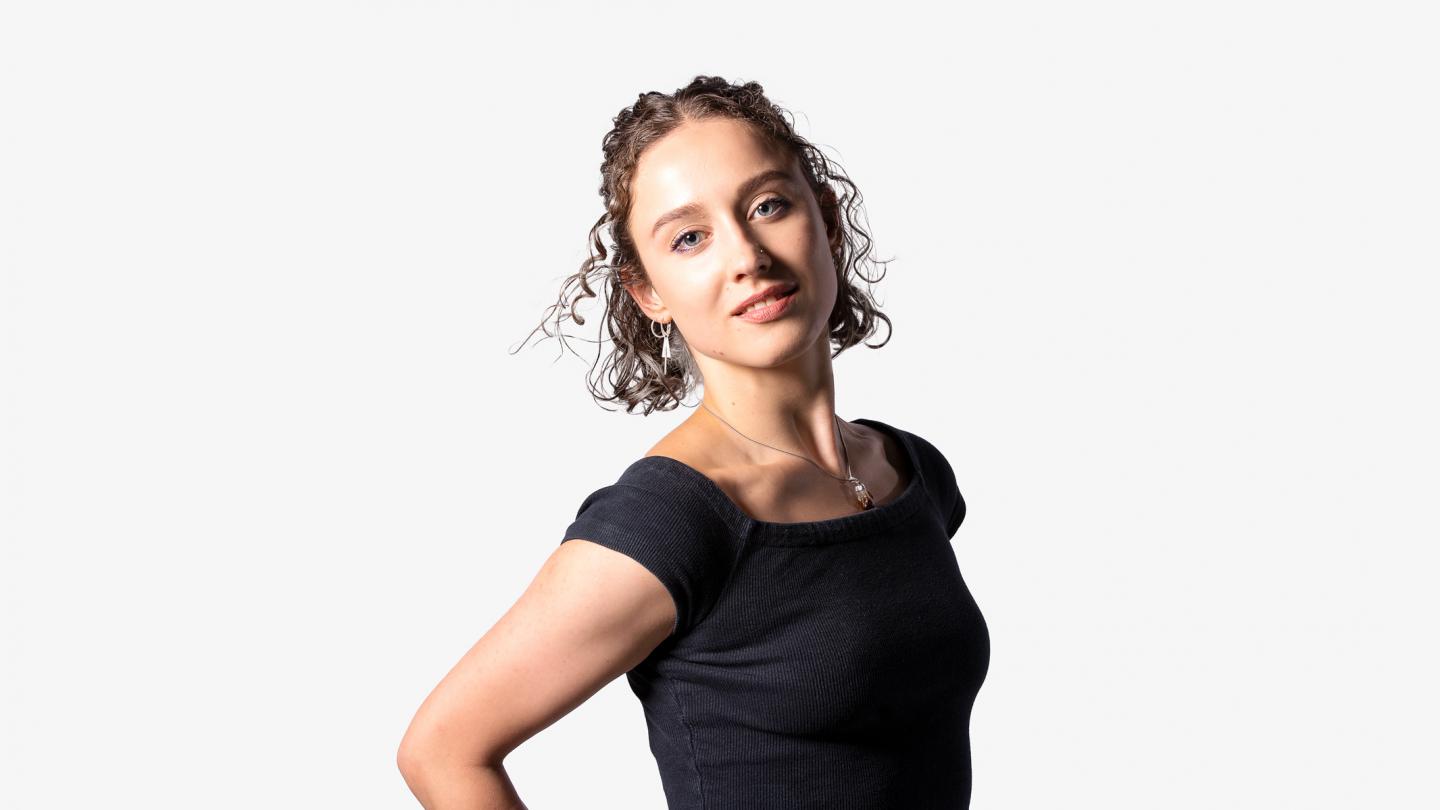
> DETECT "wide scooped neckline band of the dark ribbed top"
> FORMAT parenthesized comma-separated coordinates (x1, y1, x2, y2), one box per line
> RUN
(636, 418, 926, 545)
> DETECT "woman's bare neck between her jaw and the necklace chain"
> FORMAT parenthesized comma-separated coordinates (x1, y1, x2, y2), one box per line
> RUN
(696, 332, 847, 476)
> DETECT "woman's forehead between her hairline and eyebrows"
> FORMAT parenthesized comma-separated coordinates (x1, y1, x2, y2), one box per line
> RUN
(631, 118, 798, 214)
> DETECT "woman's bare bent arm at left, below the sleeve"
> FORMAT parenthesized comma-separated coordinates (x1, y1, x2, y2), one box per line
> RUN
(397, 539, 675, 810)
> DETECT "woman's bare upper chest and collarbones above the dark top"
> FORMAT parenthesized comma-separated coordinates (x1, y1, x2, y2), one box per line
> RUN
(645, 419, 914, 523)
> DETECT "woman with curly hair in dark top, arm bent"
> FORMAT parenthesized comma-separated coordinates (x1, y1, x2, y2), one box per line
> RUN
(399, 76, 989, 810)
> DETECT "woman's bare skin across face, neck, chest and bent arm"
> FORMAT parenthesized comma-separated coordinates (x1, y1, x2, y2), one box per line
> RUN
(397, 118, 907, 810)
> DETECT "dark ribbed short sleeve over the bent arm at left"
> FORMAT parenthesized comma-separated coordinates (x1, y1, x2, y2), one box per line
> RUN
(560, 460, 736, 637)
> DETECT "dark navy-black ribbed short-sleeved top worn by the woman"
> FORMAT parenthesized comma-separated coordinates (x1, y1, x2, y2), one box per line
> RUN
(562, 419, 989, 810)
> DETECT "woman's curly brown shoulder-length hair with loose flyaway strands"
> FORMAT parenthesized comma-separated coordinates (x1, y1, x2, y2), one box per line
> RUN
(521, 75, 893, 415)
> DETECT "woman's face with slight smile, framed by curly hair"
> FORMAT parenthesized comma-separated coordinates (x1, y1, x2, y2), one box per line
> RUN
(628, 118, 838, 379)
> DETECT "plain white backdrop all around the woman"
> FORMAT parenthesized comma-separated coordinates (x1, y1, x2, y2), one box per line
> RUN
(0, 0, 1440, 810)
